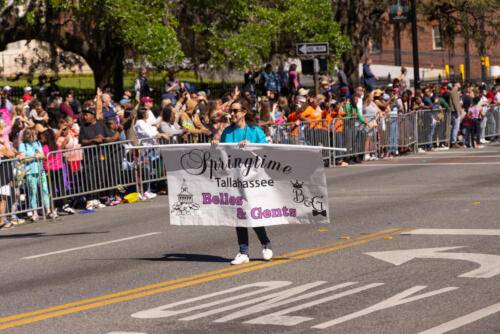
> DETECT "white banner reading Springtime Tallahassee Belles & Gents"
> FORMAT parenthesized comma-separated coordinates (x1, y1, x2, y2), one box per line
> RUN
(158, 144, 329, 227)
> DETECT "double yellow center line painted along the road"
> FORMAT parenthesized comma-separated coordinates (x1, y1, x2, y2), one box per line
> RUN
(0, 229, 405, 330)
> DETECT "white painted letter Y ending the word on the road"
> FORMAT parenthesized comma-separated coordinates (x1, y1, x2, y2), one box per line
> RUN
(312, 285, 458, 329)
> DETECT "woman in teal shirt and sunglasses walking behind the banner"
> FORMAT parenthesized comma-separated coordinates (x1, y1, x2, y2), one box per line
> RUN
(212, 100, 273, 265)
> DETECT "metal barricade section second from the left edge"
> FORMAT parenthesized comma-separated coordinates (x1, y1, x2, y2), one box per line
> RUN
(47, 141, 137, 208)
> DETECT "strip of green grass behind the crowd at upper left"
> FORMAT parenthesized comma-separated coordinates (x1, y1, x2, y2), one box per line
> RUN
(0, 71, 240, 89)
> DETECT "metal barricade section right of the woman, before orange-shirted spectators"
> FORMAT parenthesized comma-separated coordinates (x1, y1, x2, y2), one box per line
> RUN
(269, 119, 332, 165)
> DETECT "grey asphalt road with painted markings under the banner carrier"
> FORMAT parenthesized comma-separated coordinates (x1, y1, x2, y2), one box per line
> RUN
(0, 145, 500, 334)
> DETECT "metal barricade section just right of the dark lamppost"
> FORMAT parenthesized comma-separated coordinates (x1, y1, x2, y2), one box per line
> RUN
(416, 109, 451, 147)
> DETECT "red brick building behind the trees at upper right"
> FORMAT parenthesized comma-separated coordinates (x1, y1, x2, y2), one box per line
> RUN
(368, 22, 500, 80)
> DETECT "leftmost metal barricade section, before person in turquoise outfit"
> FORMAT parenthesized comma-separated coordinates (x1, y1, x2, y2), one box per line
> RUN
(0, 158, 50, 219)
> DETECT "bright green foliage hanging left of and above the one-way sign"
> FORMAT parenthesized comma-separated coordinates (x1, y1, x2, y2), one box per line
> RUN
(204, 0, 351, 69)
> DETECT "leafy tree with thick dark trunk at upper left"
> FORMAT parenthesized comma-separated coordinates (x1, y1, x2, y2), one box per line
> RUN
(0, 0, 183, 91)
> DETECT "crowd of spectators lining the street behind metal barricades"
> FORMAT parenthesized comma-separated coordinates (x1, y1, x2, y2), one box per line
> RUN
(0, 60, 500, 228)
